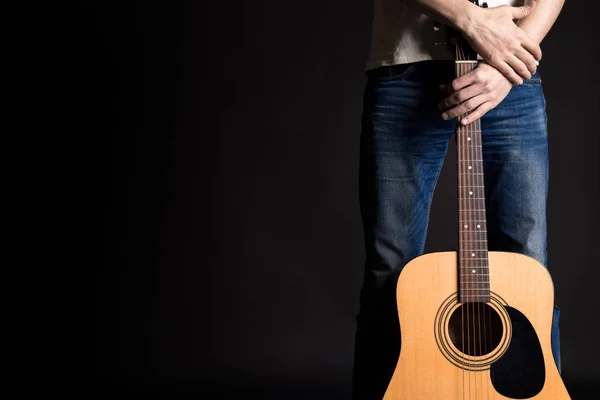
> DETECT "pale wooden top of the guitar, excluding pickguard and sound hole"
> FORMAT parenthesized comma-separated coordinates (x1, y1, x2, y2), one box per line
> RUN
(384, 252, 570, 400)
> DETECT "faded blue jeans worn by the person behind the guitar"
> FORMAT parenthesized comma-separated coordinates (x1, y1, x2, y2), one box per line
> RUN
(353, 61, 560, 400)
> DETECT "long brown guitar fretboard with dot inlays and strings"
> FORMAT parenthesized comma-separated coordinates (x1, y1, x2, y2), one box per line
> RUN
(456, 61, 490, 303)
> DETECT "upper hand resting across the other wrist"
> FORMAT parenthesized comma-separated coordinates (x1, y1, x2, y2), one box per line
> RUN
(463, 1, 542, 84)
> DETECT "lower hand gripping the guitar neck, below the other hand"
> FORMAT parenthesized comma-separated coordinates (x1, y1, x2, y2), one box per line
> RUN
(438, 62, 512, 125)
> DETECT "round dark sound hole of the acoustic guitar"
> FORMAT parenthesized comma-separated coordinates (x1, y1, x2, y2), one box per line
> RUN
(448, 303, 503, 357)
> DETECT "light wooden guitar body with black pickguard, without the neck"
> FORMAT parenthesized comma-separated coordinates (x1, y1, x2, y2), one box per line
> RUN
(384, 252, 570, 400)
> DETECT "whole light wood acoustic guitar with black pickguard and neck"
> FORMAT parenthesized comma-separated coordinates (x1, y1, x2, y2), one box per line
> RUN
(384, 1, 570, 400)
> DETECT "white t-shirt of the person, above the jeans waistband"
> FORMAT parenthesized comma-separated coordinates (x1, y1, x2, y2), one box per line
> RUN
(366, 0, 524, 70)
